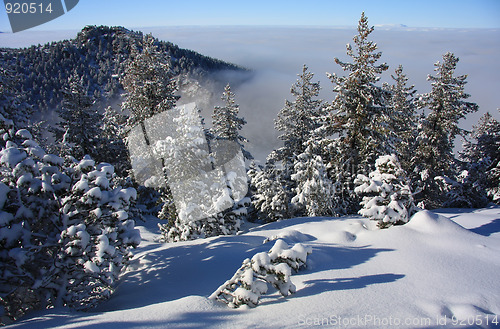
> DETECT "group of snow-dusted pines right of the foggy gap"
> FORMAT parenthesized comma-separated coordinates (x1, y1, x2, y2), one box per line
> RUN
(249, 14, 500, 227)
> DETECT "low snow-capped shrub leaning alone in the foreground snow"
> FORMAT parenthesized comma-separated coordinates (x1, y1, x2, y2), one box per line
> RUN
(209, 240, 312, 308)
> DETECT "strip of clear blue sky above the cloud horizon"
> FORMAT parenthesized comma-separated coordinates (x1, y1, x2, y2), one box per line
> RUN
(0, 0, 500, 32)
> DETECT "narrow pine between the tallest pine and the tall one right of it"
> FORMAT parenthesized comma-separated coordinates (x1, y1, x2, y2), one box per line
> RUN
(384, 65, 418, 172)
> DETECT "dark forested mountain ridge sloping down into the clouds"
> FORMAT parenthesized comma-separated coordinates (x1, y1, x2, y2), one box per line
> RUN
(0, 26, 245, 113)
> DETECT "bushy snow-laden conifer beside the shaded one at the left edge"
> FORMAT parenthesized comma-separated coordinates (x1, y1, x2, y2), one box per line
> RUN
(56, 157, 140, 309)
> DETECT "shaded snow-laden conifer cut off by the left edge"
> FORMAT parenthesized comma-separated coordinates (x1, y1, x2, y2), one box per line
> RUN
(0, 120, 70, 325)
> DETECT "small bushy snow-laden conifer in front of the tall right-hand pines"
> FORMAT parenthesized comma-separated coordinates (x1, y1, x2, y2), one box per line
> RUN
(354, 155, 415, 228)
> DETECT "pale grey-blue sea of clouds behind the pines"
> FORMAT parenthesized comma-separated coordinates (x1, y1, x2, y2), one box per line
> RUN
(149, 27, 500, 160)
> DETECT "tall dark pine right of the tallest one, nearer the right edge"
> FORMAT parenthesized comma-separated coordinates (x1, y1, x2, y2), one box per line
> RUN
(412, 52, 478, 208)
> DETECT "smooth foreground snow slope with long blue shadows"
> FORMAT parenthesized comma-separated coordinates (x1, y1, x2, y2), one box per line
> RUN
(7, 208, 500, 329)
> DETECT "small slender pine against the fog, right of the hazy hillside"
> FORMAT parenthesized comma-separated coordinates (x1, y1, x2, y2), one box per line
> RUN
(212, 84, 253, 160)
